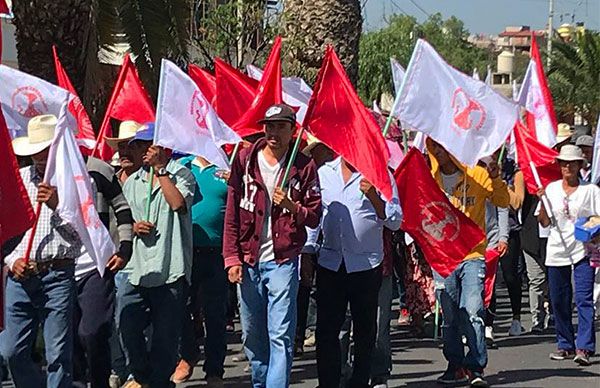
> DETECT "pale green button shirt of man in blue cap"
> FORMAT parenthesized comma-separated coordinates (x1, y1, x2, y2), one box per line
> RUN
(123, 161, 196, 287)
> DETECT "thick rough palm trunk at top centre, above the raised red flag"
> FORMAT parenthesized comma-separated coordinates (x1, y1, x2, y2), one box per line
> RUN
(284, 0, 362, 85)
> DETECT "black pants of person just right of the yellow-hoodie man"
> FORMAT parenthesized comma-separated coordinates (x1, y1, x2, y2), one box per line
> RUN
(485, 232, 523, 326)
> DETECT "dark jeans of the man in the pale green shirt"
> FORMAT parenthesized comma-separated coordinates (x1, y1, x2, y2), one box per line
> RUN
(119, 277, 187, 388)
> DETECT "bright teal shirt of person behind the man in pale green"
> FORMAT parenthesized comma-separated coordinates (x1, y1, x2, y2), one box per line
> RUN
(180, 156, 227, 247)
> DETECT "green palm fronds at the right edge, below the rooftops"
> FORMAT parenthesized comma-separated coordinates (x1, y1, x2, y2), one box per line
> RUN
(548, 31, 600, 125)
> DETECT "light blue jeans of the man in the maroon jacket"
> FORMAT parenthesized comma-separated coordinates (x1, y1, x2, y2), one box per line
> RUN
(239, 259, 299, 388)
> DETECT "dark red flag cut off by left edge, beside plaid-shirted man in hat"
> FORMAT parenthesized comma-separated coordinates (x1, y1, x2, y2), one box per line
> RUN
(0, 112, 35, 245)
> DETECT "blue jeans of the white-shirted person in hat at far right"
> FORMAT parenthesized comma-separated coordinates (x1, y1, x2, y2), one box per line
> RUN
(547, 259, 596, 352)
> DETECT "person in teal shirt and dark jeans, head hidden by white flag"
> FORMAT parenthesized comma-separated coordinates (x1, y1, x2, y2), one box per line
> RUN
(172, 156, 228, 386)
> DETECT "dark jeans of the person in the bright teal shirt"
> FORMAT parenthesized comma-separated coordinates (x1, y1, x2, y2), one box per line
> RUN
(181, 247, 228, 377)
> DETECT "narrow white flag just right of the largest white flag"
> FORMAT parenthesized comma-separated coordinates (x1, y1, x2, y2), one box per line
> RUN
(518, 58, 556, 147)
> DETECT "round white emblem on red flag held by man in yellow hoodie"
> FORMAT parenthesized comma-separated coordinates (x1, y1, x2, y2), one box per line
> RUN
(421, 201, 460, 242)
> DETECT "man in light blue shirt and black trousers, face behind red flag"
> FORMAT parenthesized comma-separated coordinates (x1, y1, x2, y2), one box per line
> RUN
(307, 158, 402, 387)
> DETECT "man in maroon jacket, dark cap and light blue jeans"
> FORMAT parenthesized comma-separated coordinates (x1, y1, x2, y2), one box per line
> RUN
(223, 104, 321, 388)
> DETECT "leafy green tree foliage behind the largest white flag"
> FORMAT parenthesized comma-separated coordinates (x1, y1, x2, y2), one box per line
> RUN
(358, 13, 493, 102)
